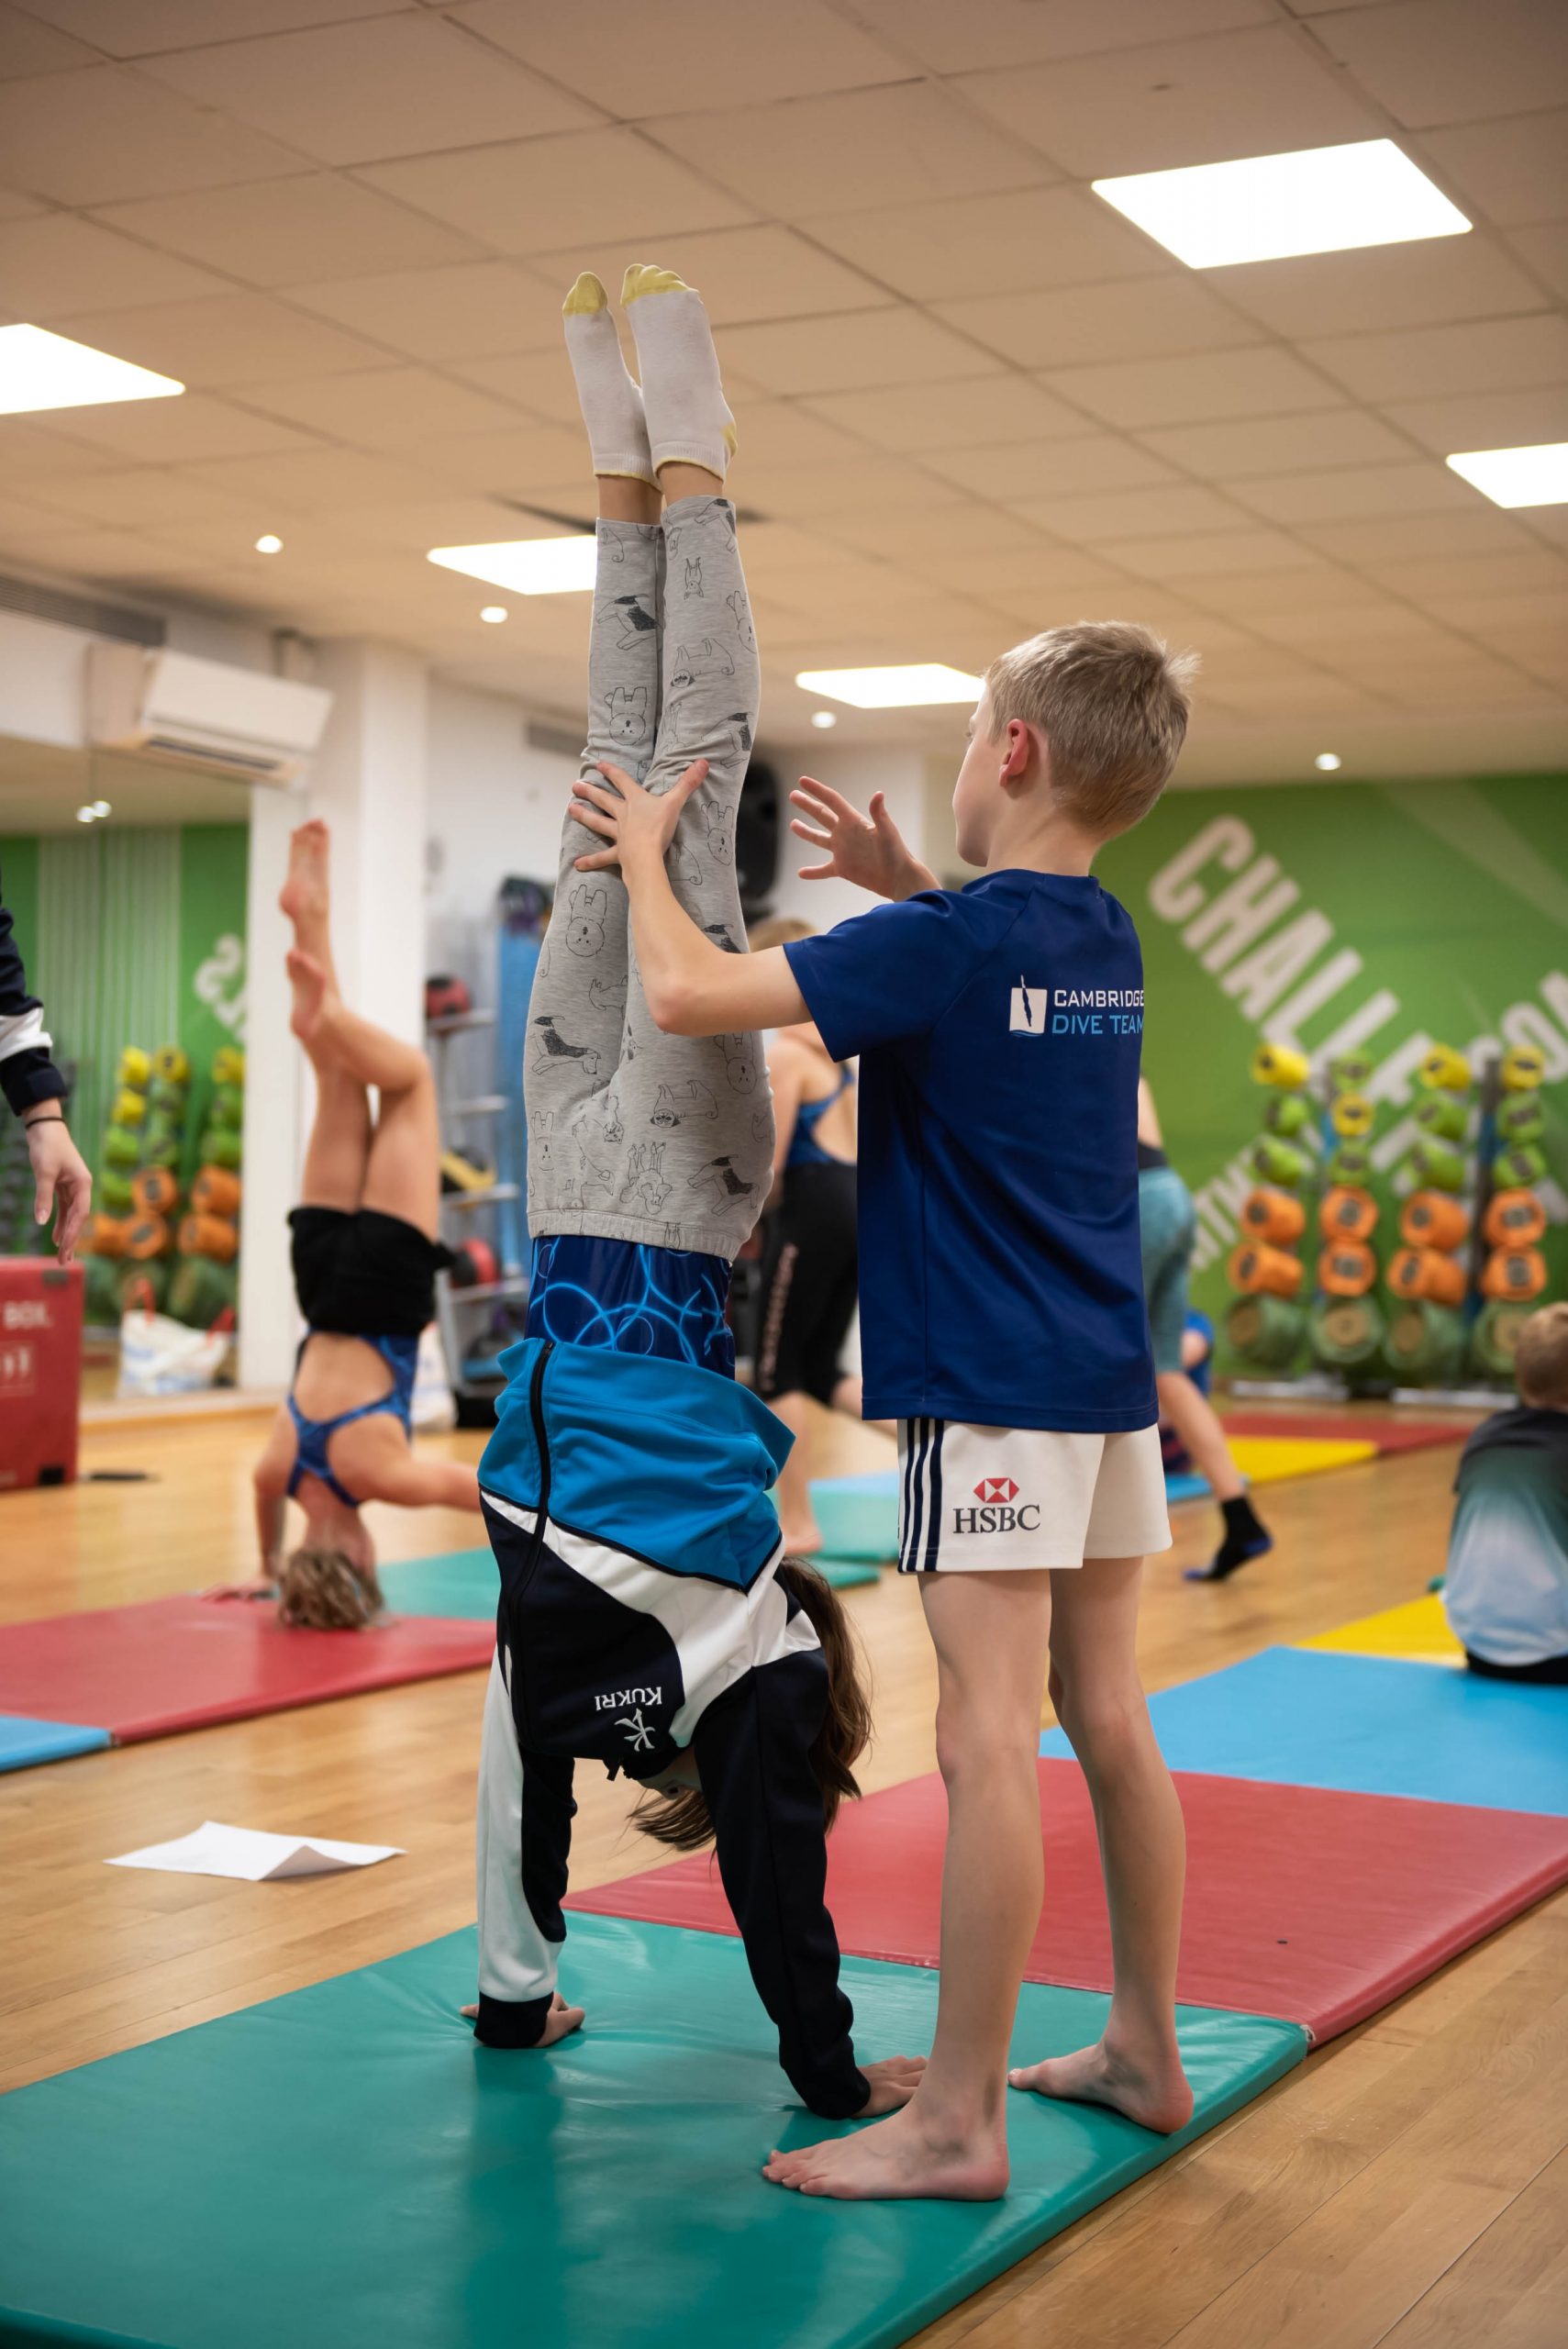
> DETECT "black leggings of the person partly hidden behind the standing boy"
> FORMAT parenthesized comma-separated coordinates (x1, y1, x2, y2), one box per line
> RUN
(756, 1165, 859, 1405)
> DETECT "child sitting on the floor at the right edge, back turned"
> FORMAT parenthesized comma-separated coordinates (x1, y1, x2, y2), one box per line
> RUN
(1443, 1304, 1568, 1687)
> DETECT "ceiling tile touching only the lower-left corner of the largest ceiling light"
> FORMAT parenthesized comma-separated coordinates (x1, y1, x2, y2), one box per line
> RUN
(932, 275, 1261, 366)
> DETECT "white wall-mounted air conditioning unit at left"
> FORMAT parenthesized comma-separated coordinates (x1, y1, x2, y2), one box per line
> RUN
(87, 643, 331, 789)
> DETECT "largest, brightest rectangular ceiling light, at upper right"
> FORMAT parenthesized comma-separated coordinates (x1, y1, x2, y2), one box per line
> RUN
(1092, 139, 1470, 270)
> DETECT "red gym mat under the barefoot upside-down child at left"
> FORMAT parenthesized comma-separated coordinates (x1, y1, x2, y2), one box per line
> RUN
(0, 1595, 495, 1745)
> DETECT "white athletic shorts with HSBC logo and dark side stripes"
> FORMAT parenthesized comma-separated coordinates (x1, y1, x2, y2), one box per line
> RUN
(899, 1419, 1172, 1574)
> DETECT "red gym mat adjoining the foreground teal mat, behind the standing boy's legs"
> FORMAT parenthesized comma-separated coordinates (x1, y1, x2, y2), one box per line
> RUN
(568, 1759, 1568, 2042)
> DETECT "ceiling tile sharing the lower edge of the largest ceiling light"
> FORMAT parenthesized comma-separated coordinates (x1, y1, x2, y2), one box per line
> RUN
(1209, 232, 1540, 336)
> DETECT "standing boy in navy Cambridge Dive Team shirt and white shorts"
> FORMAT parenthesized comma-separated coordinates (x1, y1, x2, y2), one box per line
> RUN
(580, 622, 1193, 2201)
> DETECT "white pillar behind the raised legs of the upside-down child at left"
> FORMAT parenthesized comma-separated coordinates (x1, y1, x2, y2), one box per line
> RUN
(239, 641, 428, 1388)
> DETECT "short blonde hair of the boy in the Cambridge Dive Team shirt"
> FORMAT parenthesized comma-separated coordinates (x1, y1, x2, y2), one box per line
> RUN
(986, 620, 1197, 841)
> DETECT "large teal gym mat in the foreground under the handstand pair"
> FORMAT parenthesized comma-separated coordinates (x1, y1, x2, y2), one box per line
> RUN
(0, 1917, 1307, 2349)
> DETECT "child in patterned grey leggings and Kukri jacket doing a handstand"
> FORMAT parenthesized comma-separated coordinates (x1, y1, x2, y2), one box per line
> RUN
(470, 268, 920, 2117)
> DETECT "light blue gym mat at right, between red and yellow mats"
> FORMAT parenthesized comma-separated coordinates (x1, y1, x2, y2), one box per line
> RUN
(1040, 1647, 1568, 1818)
